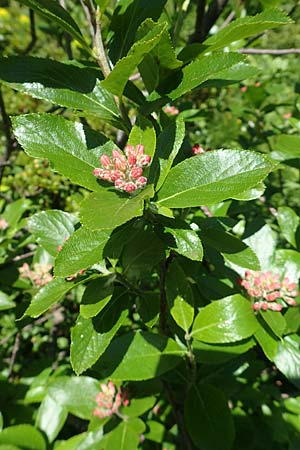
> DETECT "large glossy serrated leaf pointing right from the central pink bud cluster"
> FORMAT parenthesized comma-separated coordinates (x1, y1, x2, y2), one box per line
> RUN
(157, 150, 275, 208)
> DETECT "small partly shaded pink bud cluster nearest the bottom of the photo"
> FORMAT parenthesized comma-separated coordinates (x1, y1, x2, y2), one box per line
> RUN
(93, 381, 129, 419)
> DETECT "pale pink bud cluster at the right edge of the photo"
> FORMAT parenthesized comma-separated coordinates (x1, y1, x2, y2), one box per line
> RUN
(240, 270, 298, 311)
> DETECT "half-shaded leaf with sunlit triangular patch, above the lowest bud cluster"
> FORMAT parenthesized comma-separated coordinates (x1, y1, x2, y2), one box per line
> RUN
(94, 331, 184, 381)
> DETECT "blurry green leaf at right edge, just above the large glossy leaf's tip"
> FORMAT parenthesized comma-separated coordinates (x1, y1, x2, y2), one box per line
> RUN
(269, 134, 300, 161)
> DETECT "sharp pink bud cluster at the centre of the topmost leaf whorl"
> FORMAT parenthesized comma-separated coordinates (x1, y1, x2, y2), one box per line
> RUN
(93, 144, 151, 193)
